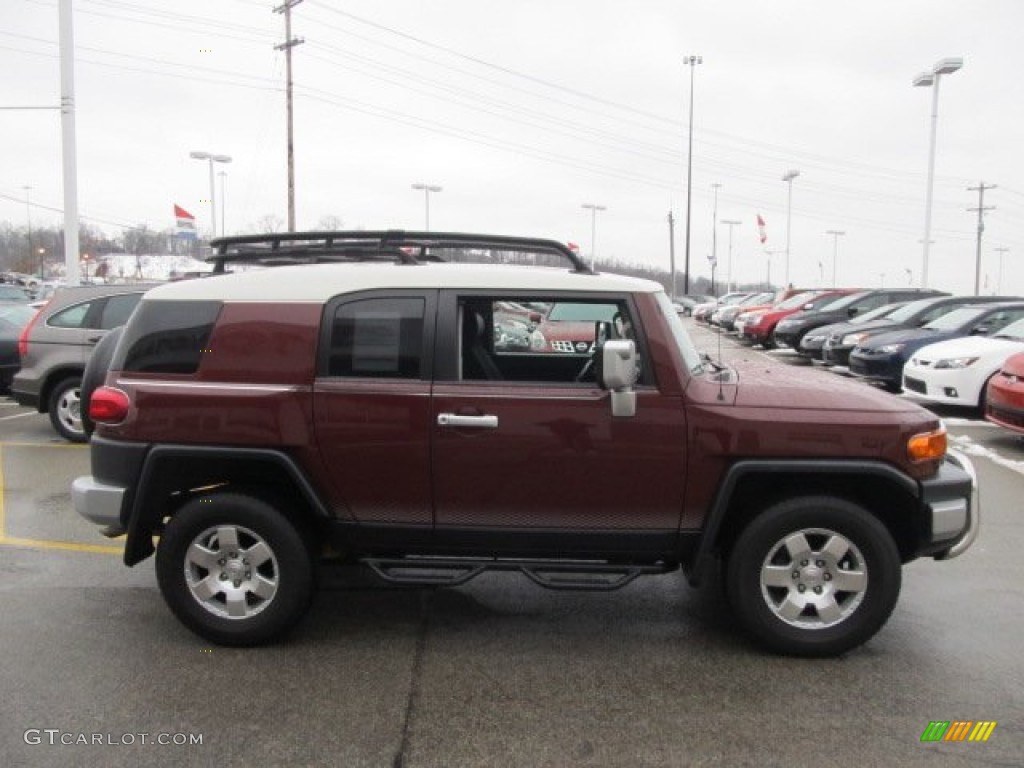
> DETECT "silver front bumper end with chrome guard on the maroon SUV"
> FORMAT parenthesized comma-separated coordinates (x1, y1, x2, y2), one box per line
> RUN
(922, 451, 981, 560)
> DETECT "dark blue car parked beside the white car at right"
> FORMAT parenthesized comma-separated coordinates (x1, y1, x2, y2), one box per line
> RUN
(850, 300, 1024, 392)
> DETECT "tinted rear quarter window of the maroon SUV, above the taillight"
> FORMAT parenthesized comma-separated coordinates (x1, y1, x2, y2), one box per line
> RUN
(111, 301, 221, 375)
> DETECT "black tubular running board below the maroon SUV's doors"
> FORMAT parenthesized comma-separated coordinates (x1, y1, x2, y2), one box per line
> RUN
(361, 557, 679, 592)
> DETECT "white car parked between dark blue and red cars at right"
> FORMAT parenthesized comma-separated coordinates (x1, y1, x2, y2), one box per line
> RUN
(903, 319, 1024, 408)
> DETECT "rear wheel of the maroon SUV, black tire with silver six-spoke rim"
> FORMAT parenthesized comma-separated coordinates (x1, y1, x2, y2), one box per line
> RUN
(157, 493, 314, 645)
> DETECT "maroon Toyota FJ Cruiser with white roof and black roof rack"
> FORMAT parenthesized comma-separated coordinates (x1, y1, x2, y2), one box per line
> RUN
(73, 231, 979, 655)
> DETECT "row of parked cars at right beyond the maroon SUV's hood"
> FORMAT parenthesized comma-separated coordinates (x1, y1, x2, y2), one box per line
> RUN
(694, 289, 1024, 434)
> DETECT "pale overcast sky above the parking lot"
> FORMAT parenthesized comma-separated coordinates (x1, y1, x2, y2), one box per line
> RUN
(0, 0, 1024, 294)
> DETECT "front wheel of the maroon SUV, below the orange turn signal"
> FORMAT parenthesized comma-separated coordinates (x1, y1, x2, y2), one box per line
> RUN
(726, 496, 902, 656)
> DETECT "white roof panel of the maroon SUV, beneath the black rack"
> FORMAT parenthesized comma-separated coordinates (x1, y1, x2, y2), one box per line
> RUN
(145, 262, 664, 302)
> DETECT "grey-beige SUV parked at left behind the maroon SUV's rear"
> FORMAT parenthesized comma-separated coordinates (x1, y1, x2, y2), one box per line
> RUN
(10, 283, 155, 442)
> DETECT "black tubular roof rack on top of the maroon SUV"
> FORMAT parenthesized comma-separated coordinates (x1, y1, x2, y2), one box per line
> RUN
(207, 229, 593, 274)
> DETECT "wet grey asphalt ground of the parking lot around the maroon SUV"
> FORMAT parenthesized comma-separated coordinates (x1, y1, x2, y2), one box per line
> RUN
(0, 331, 1024, 768)
